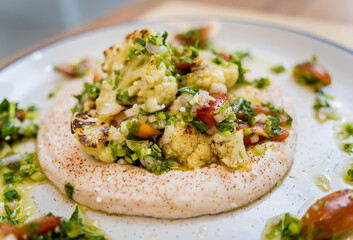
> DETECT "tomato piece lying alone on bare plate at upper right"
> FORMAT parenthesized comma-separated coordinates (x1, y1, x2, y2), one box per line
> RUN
(293, 62, 331, 85)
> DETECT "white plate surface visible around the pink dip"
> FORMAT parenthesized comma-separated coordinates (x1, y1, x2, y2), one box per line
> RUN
(0, 19, 353, 240)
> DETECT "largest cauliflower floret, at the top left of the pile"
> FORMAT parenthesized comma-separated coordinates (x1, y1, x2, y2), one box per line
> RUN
(102, 29, 178, 106)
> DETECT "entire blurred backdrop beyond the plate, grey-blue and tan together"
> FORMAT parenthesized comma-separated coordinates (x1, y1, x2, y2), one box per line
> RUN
(0, 0, 353, 66)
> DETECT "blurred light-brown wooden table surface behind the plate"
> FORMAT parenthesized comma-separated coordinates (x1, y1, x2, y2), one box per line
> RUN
(0, 0, 353, 69)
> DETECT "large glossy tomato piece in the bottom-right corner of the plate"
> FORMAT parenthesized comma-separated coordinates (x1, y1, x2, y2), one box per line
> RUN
(301, 189, 353, 240)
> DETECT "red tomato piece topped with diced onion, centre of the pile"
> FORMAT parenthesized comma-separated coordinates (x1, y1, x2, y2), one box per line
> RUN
(196, 93, 229, 128)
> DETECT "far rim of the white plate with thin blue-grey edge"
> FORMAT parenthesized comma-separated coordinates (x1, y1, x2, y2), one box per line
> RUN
(0, 16, 353, 74)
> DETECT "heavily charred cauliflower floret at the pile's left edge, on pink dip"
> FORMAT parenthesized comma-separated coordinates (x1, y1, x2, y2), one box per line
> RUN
(71, 113, 114, 163)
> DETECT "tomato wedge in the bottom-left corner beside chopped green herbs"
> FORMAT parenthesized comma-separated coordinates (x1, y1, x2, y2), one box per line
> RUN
(0, 216, 61, 240)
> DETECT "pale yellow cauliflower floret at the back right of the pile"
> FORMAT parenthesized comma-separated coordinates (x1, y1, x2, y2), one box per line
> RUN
(181, 64, 238, 91)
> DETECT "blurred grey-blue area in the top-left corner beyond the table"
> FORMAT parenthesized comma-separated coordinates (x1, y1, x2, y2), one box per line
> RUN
(0, 0, 136, 62)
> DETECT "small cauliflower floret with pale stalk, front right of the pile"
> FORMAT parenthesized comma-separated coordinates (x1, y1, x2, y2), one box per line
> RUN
(211, 130, 251, 170)
